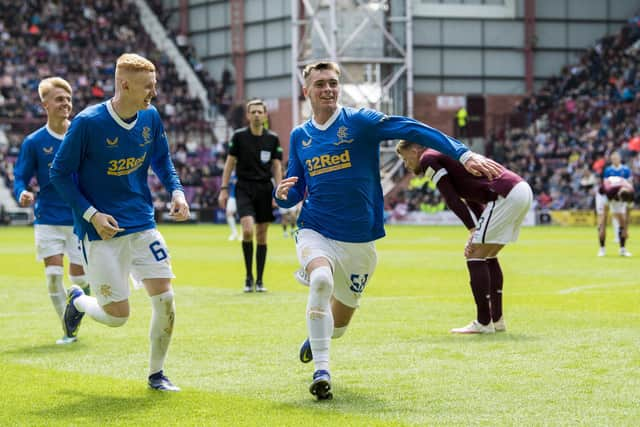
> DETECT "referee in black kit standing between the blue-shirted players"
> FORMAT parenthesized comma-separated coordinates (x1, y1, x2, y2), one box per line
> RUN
(218, 99, 282, 292)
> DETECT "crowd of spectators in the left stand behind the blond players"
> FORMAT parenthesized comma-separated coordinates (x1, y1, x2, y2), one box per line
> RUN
(0, 0, 230, 211)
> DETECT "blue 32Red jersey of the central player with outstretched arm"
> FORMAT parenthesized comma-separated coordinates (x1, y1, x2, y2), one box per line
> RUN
(276, 107, 469, 243)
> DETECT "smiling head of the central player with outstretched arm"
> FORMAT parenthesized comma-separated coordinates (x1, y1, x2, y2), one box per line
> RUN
(302, 68, 340, 115)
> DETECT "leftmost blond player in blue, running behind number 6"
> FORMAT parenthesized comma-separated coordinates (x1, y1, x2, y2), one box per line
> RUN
(13, 77, 89, 344)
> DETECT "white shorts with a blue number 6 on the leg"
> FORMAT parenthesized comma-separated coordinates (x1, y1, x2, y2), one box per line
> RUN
(82, 228, 175, 305)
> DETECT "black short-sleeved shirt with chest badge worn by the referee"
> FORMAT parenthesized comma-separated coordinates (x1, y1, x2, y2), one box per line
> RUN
(229, 127, 282, 181)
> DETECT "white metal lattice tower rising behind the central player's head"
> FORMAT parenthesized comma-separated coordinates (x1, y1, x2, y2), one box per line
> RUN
(291, 0, 414, 126)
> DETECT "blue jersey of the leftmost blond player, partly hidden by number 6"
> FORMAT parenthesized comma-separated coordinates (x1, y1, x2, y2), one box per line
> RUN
(13, 126, 73, 225)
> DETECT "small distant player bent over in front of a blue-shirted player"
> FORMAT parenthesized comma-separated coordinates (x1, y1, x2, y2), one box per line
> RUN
(596, 176, 634, 257)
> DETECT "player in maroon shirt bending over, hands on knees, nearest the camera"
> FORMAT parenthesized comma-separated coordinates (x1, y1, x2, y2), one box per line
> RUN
(396, 141, 533, 334)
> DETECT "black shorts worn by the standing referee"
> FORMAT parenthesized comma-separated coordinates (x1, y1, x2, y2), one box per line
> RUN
(236, 181, 275, 224)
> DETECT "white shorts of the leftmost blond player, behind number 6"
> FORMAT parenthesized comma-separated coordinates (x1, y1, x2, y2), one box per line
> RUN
(33, 224, 82, 265)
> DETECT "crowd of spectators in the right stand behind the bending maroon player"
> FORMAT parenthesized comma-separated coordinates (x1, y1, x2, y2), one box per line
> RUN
(387, 15, 640, 216)
